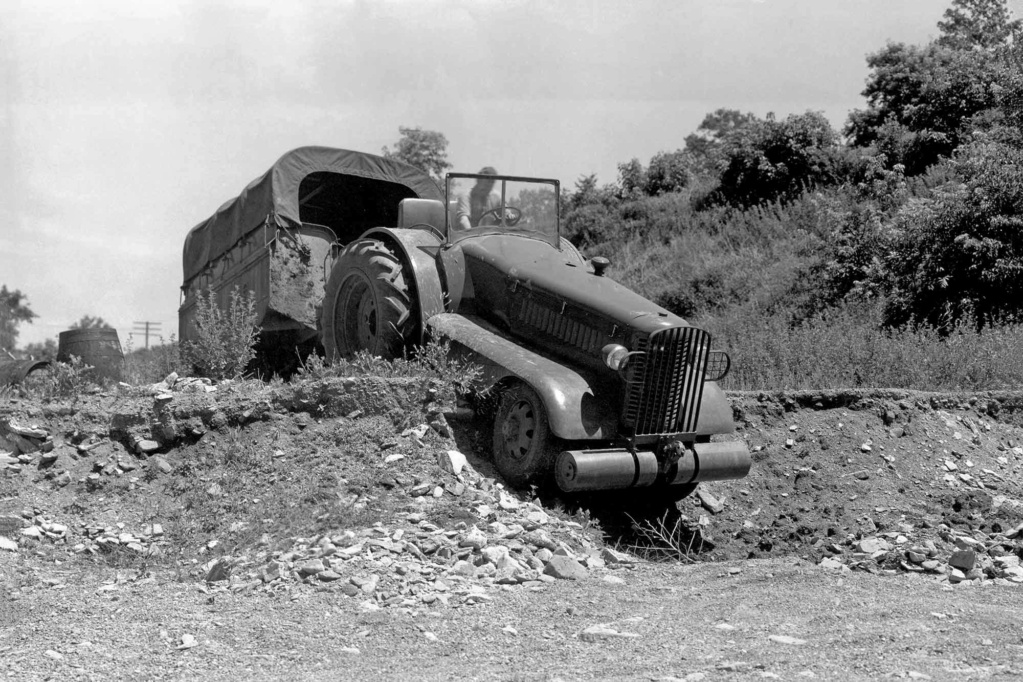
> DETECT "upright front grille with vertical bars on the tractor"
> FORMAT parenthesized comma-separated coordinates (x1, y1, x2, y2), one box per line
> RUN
(623, 327, 710, 436)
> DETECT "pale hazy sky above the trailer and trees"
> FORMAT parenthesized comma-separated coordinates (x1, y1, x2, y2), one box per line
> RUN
(0, 0, 1023, 348)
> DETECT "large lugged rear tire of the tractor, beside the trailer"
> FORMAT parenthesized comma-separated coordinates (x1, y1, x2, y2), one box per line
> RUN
(320, 239, 416, 362)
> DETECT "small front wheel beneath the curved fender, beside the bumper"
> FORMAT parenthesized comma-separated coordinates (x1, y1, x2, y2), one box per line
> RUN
(494, 383, 554, 488)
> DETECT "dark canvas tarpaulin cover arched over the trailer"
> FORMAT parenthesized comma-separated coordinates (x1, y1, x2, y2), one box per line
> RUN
(183, 146, 443, 282)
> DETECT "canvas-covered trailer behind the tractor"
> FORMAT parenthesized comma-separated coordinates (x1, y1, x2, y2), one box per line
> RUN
(178, 146, 443, 366)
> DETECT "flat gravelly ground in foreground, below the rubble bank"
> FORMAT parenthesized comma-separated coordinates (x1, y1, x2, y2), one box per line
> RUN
(0, 555, 1023, 680)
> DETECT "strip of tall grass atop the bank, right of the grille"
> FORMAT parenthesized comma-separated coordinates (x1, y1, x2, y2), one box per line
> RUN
(697, 304, 1023, 391)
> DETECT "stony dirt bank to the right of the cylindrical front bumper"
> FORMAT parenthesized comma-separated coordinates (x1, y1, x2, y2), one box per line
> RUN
(658, 391, 1023, 573)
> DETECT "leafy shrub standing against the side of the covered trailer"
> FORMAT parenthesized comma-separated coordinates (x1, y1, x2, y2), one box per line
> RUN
(180, 286, 259, 379)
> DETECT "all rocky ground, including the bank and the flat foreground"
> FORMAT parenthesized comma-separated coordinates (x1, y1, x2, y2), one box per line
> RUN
(0, 377, 1023, 679)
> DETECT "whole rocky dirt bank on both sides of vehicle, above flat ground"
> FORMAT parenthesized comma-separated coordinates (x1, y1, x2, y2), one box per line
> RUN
(6, 377, 1023, 603)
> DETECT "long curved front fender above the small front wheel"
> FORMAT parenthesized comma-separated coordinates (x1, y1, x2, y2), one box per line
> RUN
(427, 313, 618, 441)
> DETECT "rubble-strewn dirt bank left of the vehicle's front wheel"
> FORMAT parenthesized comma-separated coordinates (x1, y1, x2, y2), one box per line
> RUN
(0, 377, 605, 605)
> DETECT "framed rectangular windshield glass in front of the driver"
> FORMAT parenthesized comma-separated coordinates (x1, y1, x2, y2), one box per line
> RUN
(446, 173, 559, 246)
